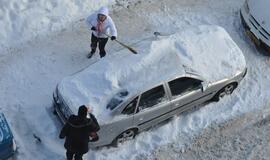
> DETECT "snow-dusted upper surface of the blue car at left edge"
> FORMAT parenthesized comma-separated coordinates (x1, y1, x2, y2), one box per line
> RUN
(0, 113, 13, 145)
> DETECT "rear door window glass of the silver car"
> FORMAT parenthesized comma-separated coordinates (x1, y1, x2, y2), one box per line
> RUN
(139, 85, 166, 110)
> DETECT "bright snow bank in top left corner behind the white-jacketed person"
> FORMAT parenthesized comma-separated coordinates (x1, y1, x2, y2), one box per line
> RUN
(0, 0, 114, 54)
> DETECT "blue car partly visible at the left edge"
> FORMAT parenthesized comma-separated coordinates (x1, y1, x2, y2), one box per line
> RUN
(0, 113, 16, 160)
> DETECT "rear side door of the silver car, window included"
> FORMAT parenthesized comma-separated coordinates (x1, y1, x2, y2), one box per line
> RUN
(134, 85, 171, 130)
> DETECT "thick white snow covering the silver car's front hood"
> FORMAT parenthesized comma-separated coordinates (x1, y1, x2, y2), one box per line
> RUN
(169, 25, 246, 83)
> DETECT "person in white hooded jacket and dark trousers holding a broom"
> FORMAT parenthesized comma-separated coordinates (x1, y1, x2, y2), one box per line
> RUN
(86, 7, 117, 58)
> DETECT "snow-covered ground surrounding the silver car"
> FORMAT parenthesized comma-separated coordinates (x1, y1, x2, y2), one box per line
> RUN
(0, 0, 270, 160)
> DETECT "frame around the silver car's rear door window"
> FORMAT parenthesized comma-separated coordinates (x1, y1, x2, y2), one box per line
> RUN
(135, 83, 170, 114)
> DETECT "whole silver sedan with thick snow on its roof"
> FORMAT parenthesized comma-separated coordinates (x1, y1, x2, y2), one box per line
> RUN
(53, 25, 247, 147)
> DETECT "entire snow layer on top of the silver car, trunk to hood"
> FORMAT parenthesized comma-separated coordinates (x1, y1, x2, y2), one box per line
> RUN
(58, 25, 246, 122)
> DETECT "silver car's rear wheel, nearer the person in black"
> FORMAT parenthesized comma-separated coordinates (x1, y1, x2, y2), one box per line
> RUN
(113, 129, 137, 146)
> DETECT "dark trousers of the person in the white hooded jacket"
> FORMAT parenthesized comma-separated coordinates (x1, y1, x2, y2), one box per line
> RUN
(91, 33, 108, 58)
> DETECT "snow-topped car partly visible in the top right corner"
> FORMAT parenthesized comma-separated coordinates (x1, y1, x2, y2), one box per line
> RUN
(240, 0, 270, 51)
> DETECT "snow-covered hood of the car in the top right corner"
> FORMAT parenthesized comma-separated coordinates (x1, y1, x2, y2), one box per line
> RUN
(248, 0, 270, 34)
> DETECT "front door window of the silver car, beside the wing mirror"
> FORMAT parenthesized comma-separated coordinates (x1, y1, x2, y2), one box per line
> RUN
(169, 77, 202, 96)
